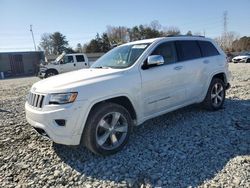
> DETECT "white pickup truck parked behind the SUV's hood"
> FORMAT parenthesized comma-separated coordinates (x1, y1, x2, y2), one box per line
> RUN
(38, 53, 89, 78)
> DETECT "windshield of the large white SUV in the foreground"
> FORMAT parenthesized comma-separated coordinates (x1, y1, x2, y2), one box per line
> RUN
(91, 43, 149, 69)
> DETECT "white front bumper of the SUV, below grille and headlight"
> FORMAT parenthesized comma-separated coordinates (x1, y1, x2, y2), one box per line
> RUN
(25, 102, 84, 145)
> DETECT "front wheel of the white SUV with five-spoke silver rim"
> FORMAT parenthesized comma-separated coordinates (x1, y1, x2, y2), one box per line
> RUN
(81, 103, 132, 156)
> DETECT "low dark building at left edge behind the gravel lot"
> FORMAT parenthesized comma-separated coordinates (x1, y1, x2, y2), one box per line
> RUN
(0, 51, 45, 77)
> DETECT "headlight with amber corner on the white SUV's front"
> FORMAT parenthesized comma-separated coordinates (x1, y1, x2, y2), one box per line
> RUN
(49, 92, 78, 104)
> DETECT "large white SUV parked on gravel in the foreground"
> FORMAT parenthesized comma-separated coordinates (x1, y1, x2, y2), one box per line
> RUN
(25, 36, 230, 155)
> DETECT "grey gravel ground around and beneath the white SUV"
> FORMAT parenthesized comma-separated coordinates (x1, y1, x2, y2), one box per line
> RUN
(0, 64, 250, 188)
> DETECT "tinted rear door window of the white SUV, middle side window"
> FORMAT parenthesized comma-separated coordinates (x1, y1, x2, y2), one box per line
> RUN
(176, 40, 201, 61)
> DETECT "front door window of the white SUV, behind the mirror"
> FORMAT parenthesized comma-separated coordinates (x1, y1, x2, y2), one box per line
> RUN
(151, 42, 176, 64)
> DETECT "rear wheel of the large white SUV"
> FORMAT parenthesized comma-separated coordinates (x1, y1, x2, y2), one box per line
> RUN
(203, 78, 226, 111)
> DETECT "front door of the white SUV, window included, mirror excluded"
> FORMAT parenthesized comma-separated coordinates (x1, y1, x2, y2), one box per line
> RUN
(141, 42, 185, 117)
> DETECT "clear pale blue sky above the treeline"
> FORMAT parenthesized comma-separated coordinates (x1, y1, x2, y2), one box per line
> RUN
(0, 0, 250, 52)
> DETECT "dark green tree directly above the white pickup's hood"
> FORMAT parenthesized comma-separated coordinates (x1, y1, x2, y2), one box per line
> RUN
(50, 32, 68, 55)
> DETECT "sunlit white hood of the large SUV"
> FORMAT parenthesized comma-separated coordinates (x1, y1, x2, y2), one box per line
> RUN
(31, 68, 124, 93)
